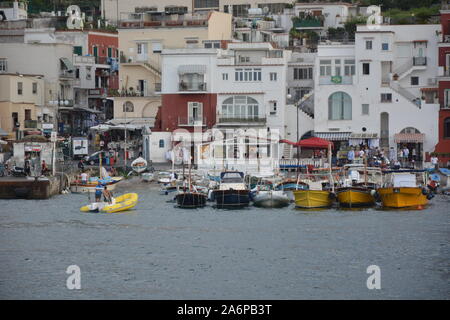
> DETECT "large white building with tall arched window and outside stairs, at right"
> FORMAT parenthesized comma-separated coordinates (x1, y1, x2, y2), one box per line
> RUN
(314, 25, 440, 160)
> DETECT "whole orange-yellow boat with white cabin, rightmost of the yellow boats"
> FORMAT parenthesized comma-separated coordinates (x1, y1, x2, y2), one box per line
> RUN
(377, 170, 431, 208)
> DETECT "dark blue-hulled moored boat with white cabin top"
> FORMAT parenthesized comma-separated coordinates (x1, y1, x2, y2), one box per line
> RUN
(213, 171, 250, 209)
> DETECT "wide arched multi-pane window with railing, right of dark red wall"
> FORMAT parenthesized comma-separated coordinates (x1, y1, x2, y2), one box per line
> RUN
(222, 96, 259, 119)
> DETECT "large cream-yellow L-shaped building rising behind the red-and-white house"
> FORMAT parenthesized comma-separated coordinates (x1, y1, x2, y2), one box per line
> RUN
(113, 12, 232, 126)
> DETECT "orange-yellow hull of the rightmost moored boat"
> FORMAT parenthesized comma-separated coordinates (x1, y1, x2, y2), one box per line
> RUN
(377, 187, 428, 208)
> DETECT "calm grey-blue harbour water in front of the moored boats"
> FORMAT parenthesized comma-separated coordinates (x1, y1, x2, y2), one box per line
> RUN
(0, 181, 450, 299)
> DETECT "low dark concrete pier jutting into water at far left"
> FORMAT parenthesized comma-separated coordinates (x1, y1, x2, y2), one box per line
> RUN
(0, 175, 65, 199)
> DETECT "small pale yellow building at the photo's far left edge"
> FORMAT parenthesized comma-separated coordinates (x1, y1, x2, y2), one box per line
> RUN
(0, 73, 44, 139)
